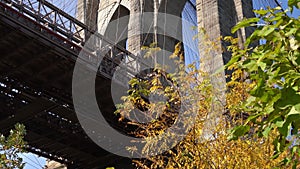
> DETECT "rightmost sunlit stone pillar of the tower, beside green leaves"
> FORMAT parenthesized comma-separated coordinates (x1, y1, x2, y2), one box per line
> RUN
(196, 0, 254, 72)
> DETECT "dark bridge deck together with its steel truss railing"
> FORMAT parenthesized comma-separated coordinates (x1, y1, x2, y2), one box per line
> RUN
(0, 0, 135, 168)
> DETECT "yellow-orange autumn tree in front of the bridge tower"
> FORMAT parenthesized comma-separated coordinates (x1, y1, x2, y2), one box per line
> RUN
(116, 37, 284, 169)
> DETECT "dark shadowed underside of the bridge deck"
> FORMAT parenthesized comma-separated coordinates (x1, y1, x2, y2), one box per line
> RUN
(0, 1, 134, 168)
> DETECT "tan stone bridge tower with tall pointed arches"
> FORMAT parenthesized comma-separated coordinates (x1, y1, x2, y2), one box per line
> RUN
(77, 0, 254, 72)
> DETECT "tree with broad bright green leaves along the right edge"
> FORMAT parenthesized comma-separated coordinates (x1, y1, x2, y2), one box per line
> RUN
(226, 0, 300, 168)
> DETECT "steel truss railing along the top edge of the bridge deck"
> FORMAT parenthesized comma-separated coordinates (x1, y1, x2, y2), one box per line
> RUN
(0, 0, 147, 82)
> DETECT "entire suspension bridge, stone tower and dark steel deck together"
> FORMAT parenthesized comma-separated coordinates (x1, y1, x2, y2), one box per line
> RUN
(0, 0, 278, 168)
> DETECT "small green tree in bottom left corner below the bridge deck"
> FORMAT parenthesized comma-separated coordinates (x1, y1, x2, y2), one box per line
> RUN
(0, 124, 26, 169)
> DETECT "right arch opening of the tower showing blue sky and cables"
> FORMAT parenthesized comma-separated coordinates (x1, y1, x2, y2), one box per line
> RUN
(157, 0, 199, 64)
